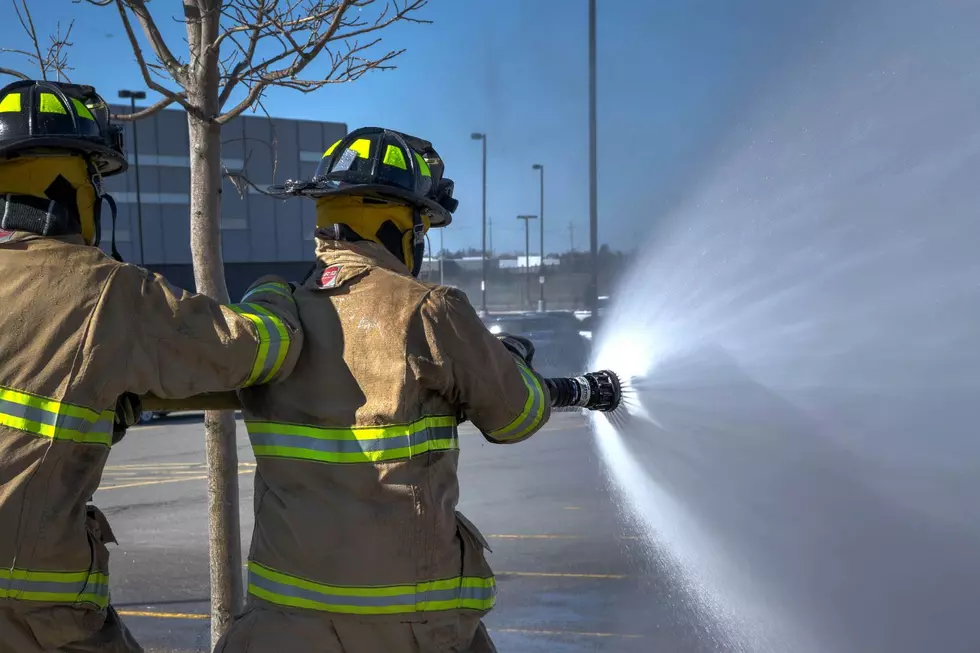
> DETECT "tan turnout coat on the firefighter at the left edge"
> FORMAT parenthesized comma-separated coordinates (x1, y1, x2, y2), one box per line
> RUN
(0, 232, 302, 649)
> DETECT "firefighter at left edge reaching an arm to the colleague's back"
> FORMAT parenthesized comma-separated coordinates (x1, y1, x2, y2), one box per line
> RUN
(0, 81, 302, 653)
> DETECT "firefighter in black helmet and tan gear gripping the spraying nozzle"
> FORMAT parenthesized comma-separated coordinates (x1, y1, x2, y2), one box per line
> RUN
(216, 128, 550, 653)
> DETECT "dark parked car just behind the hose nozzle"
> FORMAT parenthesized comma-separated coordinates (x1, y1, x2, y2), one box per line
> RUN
(483, 311, 590, 376)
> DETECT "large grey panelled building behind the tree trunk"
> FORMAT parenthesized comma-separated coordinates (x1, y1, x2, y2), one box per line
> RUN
(102, 106, 347, 298)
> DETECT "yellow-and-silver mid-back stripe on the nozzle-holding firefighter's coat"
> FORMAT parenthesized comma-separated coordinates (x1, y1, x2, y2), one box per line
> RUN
(245, 416, 459, 463)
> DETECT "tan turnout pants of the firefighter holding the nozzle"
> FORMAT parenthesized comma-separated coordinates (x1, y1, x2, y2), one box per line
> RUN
(214, 606, 497, 653)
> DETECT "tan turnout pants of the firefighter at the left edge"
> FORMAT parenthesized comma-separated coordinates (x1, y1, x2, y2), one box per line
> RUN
(0, 606, 143, 653)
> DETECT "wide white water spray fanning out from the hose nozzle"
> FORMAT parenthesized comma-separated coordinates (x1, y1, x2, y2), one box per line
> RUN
(592, 1, 980, 653)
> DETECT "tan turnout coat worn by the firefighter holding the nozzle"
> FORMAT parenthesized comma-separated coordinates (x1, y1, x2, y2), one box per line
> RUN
(234, 240, 550, 628)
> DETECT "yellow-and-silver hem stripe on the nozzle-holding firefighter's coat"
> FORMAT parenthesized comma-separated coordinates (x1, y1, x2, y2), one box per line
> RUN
(248, 560, 497, 615)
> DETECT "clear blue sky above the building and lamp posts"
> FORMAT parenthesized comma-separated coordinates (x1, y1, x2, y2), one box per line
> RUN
(0, 0, 833, 251)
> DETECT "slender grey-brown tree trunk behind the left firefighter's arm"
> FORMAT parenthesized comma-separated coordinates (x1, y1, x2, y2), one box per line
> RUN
(187, 114, 242, 647)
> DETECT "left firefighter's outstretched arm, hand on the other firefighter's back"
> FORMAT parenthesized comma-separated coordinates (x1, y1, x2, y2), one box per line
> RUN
(92, 265, 303, 402)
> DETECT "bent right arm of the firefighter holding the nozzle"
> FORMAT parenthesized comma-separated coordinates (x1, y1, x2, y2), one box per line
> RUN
(421, 288, 551, 444)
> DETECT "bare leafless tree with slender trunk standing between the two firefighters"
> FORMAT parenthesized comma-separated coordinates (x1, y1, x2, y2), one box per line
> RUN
(72, 0, 428, 644)
